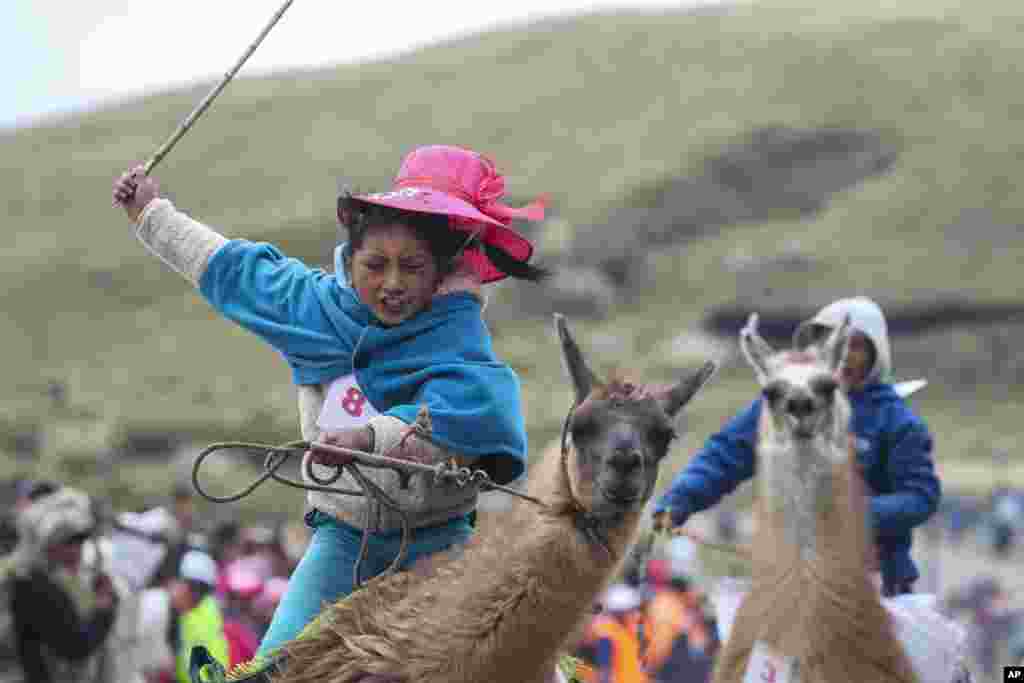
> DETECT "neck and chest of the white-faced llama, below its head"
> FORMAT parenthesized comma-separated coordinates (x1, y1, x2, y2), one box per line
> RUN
(729, 417, 915, 683)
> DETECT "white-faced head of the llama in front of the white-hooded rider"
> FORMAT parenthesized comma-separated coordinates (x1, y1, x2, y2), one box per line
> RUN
(739, 313, 850, 442)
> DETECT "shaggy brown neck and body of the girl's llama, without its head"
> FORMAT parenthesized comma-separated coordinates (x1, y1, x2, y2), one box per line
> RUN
(283, 447, 626, 683)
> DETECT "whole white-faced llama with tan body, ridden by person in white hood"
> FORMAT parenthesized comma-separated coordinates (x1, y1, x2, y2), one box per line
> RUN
(714, 314, 918, 683)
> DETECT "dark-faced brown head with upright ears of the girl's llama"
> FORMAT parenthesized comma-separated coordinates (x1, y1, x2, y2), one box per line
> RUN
(555, 313, 717, 520)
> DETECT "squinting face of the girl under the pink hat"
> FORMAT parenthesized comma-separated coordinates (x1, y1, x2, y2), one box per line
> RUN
(349, 223, 440, 326)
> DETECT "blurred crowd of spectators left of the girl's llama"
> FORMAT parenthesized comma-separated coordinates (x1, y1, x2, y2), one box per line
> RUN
(0, 480, 308, 683)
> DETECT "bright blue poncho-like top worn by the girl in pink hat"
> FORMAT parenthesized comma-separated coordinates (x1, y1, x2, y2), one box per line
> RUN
(200, 240, 526, 483)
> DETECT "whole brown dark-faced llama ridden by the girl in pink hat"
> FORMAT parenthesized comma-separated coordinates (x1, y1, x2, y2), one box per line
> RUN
(273, 315, 715, 683)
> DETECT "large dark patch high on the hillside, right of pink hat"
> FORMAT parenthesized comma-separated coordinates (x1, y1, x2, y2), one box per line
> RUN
(568, 128, 897, 287)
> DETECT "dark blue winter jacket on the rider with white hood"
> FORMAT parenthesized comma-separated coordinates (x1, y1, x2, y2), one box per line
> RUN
(654, 383, 941, 584)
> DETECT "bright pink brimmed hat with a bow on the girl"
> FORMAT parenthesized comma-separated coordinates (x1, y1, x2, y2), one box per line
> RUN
(355, 144, 545, 283)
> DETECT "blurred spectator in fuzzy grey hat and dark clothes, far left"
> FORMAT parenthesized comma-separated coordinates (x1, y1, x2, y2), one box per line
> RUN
(9, 486, 119, 683)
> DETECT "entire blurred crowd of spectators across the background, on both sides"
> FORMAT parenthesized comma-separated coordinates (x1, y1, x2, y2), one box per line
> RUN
(0, 480, 1024, 683)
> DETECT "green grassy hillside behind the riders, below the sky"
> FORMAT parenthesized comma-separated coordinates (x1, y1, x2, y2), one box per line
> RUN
(0, 0, 1024, 509)
